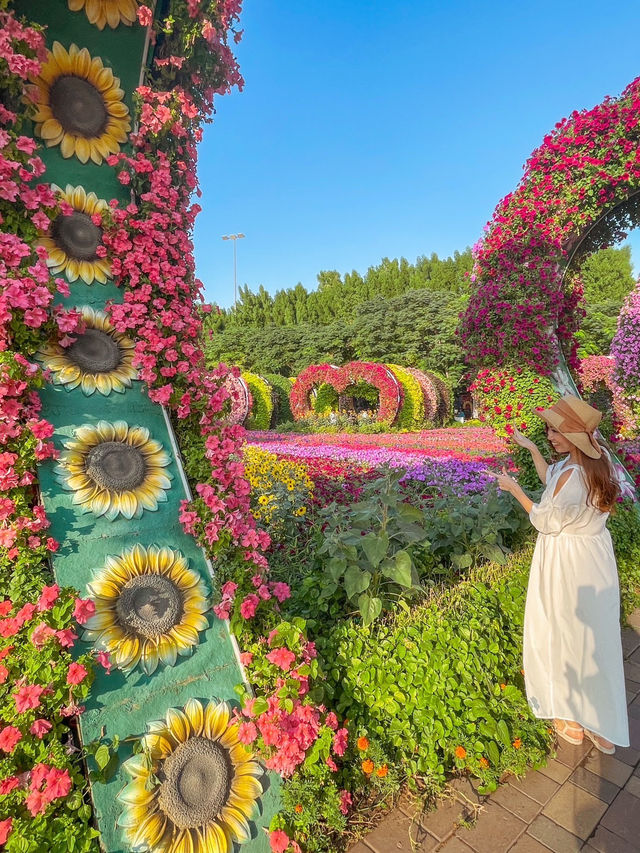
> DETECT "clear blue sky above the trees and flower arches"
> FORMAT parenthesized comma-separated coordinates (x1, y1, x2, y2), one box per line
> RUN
(194, 0, 640, 307)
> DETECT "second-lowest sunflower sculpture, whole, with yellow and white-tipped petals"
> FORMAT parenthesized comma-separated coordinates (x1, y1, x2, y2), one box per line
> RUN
(83, 545, 209, 675)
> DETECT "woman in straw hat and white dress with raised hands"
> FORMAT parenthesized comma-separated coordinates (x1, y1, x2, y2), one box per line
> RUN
(496, 394, 629, 754)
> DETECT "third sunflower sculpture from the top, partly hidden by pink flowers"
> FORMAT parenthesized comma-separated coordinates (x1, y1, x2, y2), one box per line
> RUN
(38, 184, 111, 284)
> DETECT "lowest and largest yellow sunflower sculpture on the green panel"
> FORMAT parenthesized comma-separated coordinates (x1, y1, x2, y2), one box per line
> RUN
(118, 699, 263, 853)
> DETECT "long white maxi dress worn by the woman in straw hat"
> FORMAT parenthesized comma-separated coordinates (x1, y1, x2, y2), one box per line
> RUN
(523, 457, 629, 746)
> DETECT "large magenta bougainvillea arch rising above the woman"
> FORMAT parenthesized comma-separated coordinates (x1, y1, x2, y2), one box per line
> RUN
(460, 78, 640, 391)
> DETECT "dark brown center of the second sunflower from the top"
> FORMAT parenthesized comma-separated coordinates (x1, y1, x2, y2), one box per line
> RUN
(49, 74, 109, 139)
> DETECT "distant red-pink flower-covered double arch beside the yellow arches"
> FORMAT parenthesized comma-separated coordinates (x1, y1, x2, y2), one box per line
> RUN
(289, 361, 403, 423)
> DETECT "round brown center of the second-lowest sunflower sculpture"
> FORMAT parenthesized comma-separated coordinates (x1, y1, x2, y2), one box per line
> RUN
(116, 573, 184, 640)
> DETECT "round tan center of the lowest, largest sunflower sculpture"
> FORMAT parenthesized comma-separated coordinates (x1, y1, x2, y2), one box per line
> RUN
(158, 737, 233, 829)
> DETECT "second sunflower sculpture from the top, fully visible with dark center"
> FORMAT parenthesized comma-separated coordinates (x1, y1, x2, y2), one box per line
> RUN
(31, 41, 131, 165)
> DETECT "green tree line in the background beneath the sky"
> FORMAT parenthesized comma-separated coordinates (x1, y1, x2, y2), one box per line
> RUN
(204, 247, 635, 386)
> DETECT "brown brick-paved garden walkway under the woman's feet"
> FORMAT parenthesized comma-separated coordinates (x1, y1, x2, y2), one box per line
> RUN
(350, 610, 640, 853)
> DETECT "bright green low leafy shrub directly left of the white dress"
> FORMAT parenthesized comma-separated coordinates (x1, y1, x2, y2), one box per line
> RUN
(316, 548, 551, 790)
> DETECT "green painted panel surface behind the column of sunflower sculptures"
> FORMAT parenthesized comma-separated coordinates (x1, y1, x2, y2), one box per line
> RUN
(14, 0, 279, 853)
